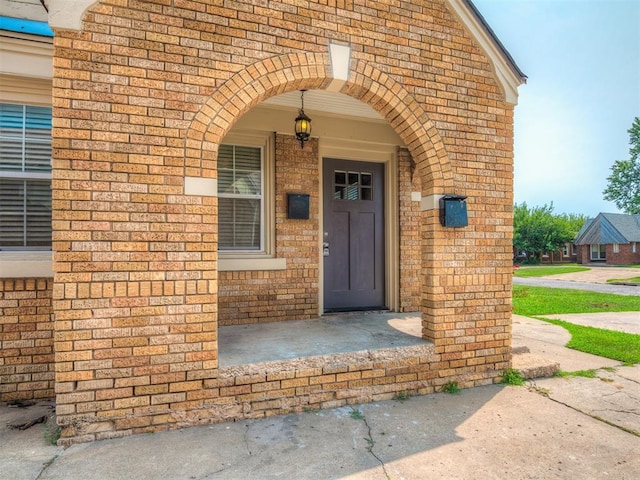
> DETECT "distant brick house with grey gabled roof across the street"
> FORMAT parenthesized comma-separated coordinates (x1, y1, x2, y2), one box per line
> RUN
(575, 213, 640, 265)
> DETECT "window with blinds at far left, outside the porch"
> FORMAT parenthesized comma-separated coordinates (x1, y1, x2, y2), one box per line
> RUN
(0, 103, 51, 250)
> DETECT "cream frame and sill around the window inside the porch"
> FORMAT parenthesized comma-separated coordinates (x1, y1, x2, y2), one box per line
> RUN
(218, 132, 287, 271)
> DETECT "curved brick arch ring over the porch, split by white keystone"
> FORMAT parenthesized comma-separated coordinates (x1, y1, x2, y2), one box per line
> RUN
(185, 53, 453, 195)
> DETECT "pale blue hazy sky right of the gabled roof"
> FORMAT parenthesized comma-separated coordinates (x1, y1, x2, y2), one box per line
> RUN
(472, 0, 640, 217)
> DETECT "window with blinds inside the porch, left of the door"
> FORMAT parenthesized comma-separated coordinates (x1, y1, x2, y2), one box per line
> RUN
(218, 144, 264, 252)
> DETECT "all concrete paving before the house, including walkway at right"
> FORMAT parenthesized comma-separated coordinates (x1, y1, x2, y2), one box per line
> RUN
(0, 317, 640, 480)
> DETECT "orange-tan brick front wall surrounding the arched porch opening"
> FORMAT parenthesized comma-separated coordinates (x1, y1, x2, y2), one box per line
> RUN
(47, 0, 513, 440)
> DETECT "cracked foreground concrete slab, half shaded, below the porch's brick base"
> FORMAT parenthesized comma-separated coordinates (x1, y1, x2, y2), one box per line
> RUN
(2, 378, 640, 480)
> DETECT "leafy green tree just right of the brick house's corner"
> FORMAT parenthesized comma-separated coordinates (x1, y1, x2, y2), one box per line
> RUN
(513, 202, 587, 263)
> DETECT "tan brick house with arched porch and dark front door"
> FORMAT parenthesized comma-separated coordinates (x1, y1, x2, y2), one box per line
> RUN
(0, 0, 525, 444)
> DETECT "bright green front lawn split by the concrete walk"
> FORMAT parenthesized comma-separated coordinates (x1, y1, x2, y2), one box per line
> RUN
(513, 285, 640, 364)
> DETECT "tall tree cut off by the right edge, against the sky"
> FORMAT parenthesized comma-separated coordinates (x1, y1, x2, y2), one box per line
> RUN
(602, 117, 640, 213)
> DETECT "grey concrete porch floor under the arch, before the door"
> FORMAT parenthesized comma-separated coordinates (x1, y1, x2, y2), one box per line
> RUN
(218, 312, 431, 368)
